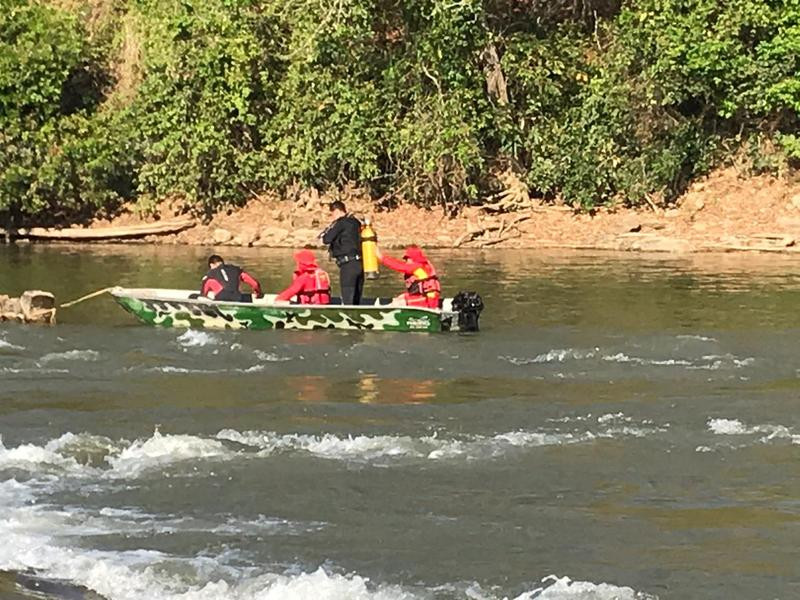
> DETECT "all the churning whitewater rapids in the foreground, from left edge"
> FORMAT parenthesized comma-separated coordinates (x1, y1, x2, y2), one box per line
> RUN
(0, 426, 655, 600)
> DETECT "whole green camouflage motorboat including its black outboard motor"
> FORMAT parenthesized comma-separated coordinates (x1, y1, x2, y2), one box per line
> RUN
(111, 287, 483, 333)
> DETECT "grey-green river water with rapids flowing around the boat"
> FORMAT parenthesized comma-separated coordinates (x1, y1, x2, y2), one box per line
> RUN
(0, 246, 800, 600)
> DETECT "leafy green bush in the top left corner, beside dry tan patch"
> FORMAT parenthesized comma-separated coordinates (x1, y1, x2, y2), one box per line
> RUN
(0, 0, 136, 219)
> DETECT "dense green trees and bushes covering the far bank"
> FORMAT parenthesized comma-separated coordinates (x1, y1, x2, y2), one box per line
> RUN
(0, 0, 800, 221)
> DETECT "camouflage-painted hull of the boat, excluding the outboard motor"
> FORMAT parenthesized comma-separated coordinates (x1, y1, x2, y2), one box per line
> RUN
(112, 289, 456, 333)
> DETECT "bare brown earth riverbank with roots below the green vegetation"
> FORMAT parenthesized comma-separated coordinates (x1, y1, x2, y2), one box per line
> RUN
(9, 169, 800, 253)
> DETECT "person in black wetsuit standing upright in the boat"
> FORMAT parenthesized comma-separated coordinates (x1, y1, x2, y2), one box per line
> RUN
(320, 200, 364, 304)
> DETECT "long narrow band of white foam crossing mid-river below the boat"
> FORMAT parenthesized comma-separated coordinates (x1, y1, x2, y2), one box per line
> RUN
(0, 413, 664, 479)
